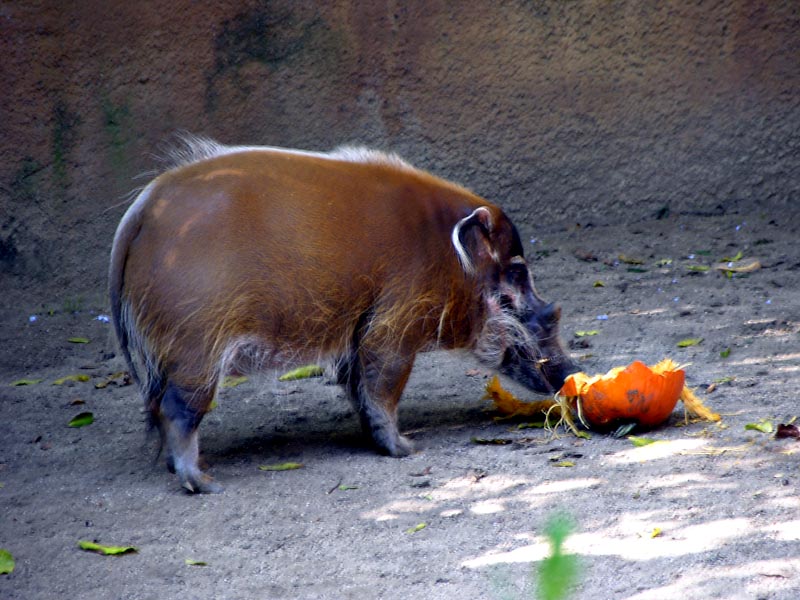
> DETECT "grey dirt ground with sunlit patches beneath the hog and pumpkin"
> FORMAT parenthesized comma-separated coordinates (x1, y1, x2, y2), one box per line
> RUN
(0, 212, 800, 600)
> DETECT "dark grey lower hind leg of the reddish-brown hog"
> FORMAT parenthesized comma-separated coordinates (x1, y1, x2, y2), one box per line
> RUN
(154, 381, 223, 494)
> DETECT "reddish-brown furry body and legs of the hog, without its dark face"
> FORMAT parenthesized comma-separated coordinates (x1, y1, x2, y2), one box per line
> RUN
(110, 142, 576, 491)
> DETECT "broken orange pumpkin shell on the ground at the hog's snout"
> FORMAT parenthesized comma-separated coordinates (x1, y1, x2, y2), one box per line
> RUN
(558, 359, 685, 429)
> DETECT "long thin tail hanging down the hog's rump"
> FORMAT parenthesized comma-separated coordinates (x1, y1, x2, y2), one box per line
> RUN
(108, 182, 164, 414)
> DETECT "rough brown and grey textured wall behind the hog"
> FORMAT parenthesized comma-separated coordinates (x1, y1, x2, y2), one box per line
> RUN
(0, 0, 800, 300)
